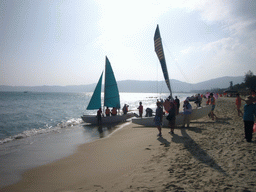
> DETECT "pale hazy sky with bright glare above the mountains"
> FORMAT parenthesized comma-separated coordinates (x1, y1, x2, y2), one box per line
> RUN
(0, 0, 256, 86)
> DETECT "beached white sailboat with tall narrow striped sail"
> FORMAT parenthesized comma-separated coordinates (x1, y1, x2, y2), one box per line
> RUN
(132, 25, 211, 127)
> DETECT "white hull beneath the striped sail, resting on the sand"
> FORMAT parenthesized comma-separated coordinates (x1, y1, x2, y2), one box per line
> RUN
(132, 105, 212, 127)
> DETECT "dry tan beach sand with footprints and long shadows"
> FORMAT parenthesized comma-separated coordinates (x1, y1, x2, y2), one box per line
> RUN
(0, 98, 256, 192)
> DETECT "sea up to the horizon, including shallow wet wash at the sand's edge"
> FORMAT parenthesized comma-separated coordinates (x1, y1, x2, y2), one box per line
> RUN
(0, 92, 193, 188)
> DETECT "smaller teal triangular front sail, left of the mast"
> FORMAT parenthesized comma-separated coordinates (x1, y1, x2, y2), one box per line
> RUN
(86, 72, 103, 110)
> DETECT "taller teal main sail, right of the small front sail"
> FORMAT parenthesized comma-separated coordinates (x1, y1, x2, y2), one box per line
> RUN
(104, 57, 120, 109)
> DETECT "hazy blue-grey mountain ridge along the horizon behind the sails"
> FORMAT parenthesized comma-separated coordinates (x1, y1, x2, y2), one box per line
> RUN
(0, 76, 244, 93)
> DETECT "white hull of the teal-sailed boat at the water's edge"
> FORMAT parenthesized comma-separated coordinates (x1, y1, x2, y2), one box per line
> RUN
(81, 113, 134, 125)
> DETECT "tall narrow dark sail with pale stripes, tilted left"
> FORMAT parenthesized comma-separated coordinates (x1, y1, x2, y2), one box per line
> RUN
(154, 25, 172, 96)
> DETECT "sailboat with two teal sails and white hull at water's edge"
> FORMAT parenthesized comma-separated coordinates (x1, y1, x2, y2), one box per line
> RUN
(81, 56, 133, 125)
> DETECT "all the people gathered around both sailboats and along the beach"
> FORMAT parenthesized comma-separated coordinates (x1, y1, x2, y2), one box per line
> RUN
(97, 90, 256, 142)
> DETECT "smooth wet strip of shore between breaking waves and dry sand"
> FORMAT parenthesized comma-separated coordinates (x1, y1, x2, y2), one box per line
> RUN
(0, 122, 133, 189)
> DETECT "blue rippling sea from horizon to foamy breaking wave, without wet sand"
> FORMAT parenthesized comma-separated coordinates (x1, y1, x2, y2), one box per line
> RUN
(0, 92, 191, 144)
